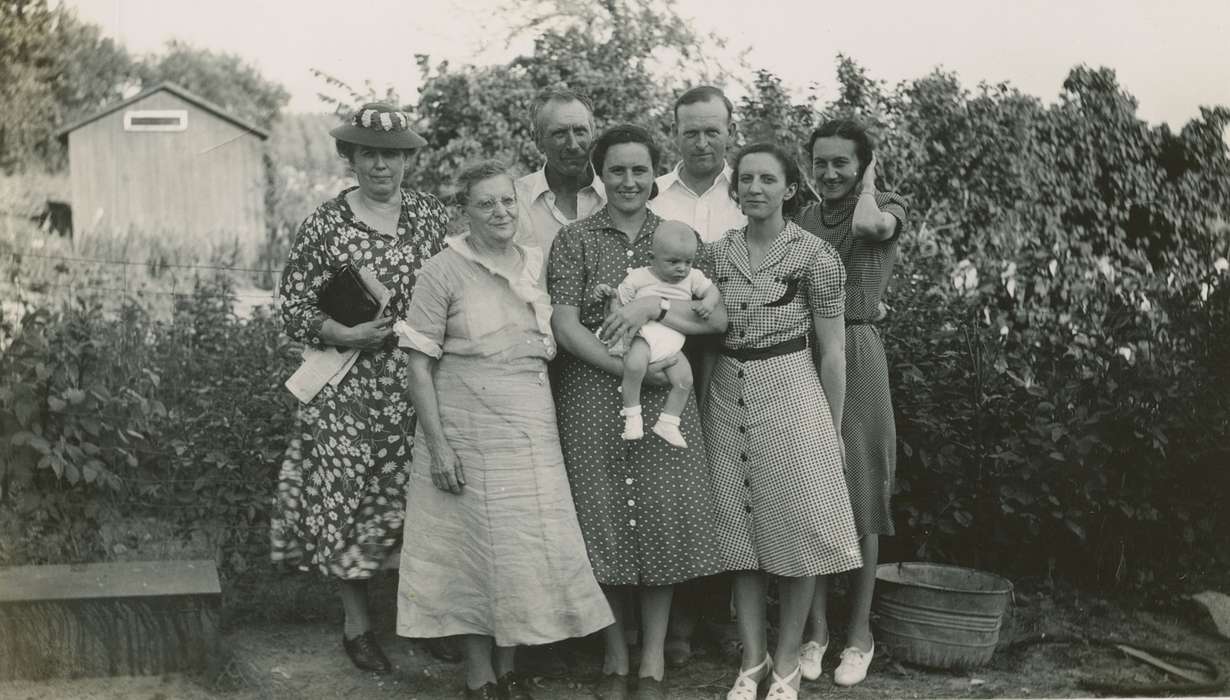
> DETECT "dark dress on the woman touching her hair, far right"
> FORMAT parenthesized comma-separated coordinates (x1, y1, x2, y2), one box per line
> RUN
(797, 192, 907, 535)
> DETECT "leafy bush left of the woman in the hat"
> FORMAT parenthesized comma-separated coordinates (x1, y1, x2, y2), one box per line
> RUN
(0, 270, 294, 576)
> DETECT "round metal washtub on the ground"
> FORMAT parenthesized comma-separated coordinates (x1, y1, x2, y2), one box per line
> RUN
(875, 562, 1012, 669)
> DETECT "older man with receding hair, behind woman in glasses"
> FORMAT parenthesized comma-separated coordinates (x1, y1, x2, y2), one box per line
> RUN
(515, 87, 606, 255)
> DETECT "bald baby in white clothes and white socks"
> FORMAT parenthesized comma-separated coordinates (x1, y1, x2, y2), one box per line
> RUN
(594, 221, 722, 448)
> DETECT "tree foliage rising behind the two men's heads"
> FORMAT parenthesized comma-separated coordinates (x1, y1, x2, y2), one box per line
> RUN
(407, 0, 738, 191)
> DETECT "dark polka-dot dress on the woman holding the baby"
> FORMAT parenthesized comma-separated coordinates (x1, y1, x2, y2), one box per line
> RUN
(547, 208, 718, 586)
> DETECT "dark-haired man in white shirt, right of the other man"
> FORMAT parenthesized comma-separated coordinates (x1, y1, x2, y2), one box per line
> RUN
(649, 85, 748, 242)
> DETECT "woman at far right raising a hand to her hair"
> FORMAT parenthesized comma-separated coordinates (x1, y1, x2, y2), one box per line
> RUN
(796, 119, 907, 685)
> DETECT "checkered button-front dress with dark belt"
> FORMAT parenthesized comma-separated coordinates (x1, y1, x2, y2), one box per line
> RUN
(704, 224, 862, 576)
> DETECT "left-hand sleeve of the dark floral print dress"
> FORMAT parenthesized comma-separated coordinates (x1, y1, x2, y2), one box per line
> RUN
(278, 207, 333, 346)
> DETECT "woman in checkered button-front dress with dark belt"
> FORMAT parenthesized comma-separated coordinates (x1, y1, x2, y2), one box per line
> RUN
(702, 144, 862, 700)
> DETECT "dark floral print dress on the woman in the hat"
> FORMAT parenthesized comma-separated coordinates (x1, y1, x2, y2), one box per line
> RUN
(271, 188, 448, 579)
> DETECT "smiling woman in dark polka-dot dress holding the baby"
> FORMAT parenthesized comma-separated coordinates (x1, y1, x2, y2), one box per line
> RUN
(547, 125, 726, 699)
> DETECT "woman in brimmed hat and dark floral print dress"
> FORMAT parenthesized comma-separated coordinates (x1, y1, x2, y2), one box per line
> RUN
(272, 102, 448, 673)
